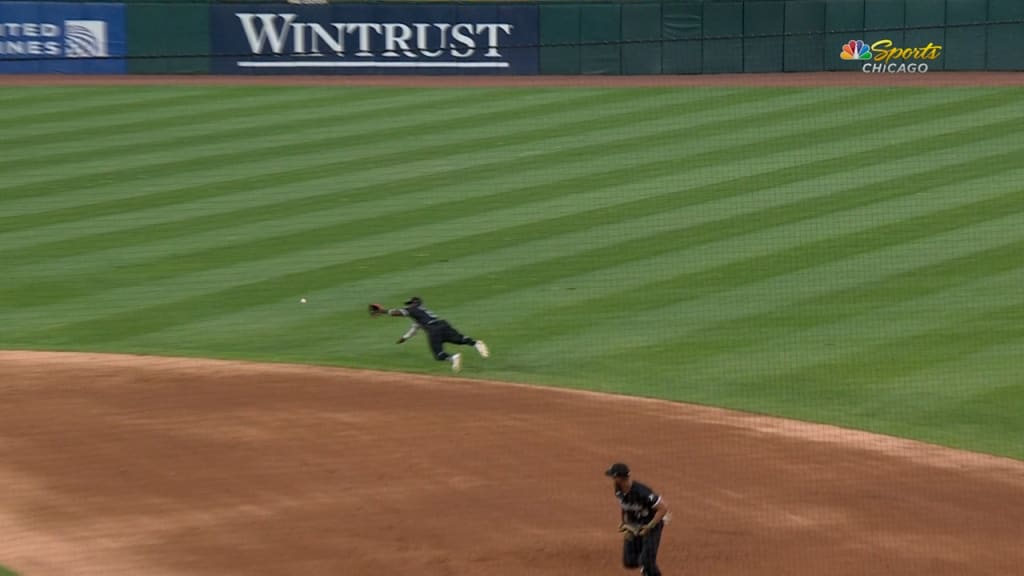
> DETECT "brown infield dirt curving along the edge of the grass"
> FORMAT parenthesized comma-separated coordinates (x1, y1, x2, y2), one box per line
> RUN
(0, 353, 1024, 576)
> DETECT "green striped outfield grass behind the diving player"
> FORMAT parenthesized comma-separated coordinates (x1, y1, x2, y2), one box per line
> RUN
(0, 87, 1024, 458)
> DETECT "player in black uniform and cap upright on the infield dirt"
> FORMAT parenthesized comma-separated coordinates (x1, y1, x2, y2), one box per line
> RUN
(604, 462, 669, 576)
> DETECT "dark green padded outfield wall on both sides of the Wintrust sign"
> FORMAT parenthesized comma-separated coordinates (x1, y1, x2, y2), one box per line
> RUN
(126, 0, 1024, 75)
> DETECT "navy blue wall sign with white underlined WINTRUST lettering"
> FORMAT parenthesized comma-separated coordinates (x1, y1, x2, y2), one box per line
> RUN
(210, 4, 538, 74)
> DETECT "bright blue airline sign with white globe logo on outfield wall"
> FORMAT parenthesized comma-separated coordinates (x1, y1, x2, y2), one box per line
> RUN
(0, 2, 126, 74)
